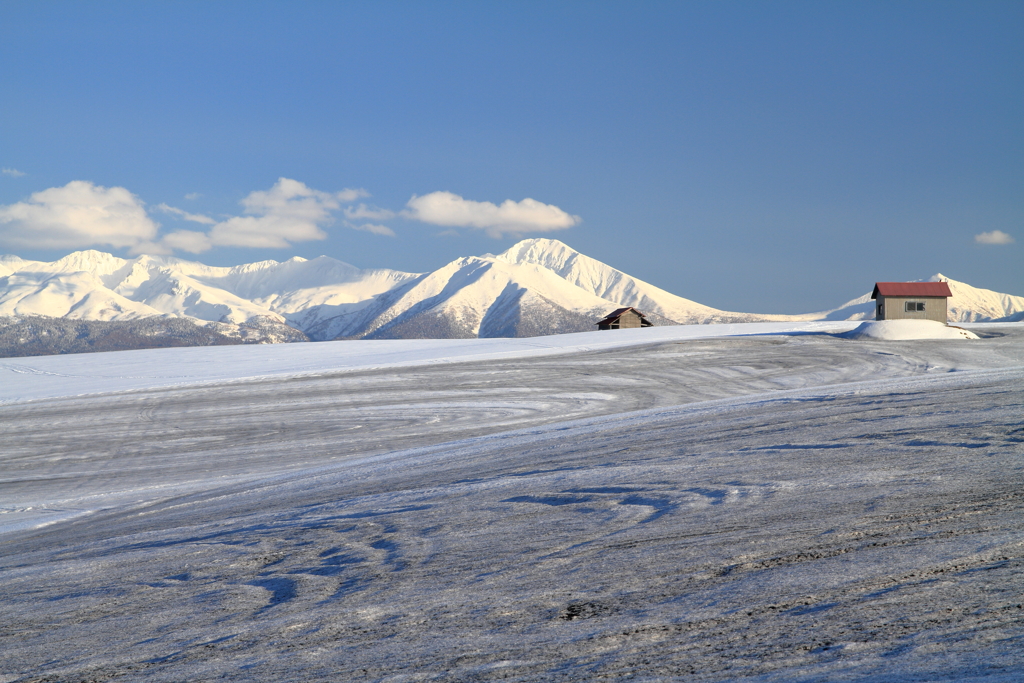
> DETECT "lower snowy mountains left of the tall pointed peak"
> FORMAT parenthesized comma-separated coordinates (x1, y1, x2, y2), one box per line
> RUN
(0, 250, 418, 337)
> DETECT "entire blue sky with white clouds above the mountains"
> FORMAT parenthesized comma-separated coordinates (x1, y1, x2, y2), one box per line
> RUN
(0, 0, 1024, 313)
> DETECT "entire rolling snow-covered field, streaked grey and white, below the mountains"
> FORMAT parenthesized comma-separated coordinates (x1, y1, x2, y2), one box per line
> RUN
(0, 323, 1024, 683)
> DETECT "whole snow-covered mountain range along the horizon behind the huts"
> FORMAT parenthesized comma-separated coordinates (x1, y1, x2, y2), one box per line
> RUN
(0, 239, 1024, 356)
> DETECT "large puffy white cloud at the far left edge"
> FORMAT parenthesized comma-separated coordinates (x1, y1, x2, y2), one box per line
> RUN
(0, 180, 159, 249)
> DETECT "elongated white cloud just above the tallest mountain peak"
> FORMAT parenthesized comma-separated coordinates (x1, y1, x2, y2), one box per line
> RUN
(402, 193, 583, 238)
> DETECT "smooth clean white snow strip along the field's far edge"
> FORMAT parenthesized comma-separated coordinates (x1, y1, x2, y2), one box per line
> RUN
(0, 323, 856, 404)
